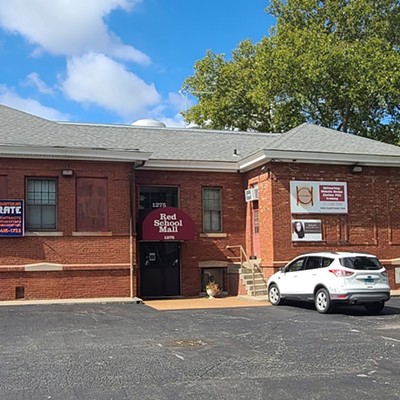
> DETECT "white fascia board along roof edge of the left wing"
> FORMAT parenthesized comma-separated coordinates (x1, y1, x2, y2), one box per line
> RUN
(0, 146, 152, 162)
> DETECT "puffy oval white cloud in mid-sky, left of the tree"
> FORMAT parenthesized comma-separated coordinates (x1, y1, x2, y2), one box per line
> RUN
(61, 53, 161, 119)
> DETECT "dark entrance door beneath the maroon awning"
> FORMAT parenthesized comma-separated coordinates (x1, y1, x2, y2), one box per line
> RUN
(140, 242, 180, 297)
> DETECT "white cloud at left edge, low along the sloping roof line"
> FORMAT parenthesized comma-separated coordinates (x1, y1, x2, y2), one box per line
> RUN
(0, 85, 69, 121)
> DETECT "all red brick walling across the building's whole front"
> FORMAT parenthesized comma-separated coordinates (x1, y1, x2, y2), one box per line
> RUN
(0, 159, 400, 299)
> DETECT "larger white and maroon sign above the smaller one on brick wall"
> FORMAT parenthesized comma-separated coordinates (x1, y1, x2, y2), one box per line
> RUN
(290, 181, 347, 214)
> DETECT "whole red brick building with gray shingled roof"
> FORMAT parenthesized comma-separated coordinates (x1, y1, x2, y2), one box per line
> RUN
(0, 106, 400, 300)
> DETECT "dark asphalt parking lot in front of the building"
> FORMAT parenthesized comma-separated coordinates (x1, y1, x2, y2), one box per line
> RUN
(0, 298, 400, 400)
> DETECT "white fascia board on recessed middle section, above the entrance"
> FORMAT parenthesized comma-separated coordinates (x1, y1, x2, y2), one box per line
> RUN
(140, 160, 239, 172)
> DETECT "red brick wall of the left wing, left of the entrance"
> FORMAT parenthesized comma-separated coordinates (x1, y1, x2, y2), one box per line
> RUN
(0, 158, 134, 300)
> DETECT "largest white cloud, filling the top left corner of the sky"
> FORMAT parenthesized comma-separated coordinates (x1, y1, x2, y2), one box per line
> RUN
(0, 0, 150, 64)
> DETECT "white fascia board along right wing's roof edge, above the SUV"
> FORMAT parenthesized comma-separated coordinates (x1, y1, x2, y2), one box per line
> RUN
(239, 150, 400, 172)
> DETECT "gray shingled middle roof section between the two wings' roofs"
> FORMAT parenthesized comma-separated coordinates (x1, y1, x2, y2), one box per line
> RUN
(60, 124, 280, 161)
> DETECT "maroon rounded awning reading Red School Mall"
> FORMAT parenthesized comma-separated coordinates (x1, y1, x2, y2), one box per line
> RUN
(142, 207, 196, 241)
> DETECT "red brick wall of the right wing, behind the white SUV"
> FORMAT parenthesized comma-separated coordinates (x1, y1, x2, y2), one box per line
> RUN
(247, 163, 400, 288)
